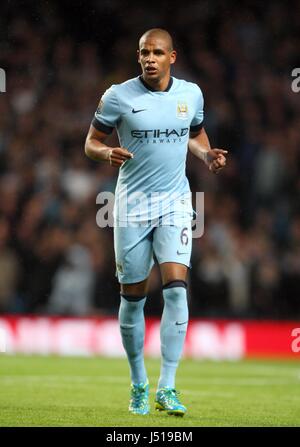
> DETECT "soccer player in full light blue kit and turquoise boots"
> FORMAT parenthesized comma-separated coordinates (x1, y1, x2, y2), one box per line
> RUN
(85, 28, 227, 416)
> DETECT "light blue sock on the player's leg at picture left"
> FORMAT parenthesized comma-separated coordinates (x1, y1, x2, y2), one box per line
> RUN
(119, 295, 147, 384)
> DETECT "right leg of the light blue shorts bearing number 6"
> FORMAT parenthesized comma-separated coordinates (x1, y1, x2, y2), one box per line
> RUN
(153, 222, 192, 279)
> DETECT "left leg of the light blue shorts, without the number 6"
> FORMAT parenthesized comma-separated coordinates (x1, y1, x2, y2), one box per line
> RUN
(114, 226, 154, 289)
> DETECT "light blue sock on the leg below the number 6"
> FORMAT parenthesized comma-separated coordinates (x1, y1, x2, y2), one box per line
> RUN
(158, 281, 189, 389)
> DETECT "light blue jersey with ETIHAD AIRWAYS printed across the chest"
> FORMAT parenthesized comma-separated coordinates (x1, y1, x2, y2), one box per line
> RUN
(92, 76, 203, 222)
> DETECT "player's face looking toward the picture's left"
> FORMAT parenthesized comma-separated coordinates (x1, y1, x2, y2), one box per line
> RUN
(138, 37, 176, 83)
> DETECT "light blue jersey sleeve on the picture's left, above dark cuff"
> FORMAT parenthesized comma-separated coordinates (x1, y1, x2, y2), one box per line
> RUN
(92, 86, 120, 134)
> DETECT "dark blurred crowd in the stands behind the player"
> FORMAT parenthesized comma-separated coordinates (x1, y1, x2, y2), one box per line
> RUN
(0, 0, 300, 318)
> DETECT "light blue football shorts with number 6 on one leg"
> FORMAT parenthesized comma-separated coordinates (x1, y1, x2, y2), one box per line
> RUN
(114, 217, 192, 284)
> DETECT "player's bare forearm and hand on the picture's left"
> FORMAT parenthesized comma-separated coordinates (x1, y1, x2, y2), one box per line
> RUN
(84, 124, 133, 168)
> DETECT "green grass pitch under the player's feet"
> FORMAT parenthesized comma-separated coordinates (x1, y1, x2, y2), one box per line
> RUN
(0, 354, 300, 427)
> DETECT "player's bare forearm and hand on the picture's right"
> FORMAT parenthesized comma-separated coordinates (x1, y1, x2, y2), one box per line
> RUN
(188, 127, 228, 174)
